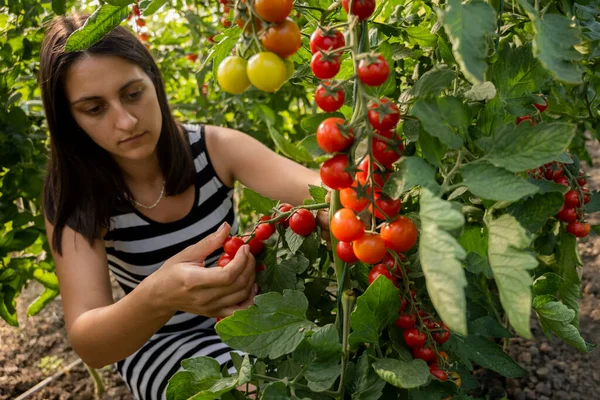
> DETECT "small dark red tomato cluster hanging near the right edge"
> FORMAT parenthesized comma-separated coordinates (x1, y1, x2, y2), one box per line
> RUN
(531, 162, 591, 237)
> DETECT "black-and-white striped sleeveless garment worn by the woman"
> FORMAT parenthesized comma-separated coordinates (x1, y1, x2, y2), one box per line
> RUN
(104, 125, 237, 400)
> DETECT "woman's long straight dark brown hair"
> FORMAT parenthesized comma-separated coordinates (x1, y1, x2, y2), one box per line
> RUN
(39, 14, 194, 254)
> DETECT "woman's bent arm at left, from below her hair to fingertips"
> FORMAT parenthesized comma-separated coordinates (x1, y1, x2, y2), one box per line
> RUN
(46, 220, 255, 368)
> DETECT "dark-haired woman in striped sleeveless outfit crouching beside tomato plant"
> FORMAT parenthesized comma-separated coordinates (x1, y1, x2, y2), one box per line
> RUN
(40, 15, 327, 399)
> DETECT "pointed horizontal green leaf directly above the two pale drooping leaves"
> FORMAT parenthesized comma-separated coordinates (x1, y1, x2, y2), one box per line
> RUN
(461, 163, 539, 202)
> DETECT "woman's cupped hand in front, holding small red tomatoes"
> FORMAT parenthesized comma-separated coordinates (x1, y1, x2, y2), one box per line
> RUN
(148, 223, 258, 317)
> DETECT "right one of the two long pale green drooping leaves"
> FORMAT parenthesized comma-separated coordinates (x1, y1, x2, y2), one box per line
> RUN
(488, 214, 538, 338)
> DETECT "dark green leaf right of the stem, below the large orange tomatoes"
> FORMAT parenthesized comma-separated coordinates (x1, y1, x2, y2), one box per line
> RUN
(349, 277, 400, 347)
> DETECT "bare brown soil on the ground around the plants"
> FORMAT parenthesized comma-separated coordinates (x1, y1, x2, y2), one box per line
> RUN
(0, 143, 600, 400)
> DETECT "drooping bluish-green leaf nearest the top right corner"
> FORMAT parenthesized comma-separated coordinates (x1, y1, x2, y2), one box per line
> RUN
(519, 0, 583, 84)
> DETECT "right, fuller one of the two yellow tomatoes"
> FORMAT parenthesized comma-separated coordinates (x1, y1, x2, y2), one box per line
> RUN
(247, 51, 287, 92)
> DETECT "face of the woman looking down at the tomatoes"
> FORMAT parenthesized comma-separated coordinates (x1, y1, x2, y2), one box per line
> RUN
(64, 55, 162, 163)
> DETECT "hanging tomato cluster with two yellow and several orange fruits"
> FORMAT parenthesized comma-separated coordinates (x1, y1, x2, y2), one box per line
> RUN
(217, 0, 302, 94)
